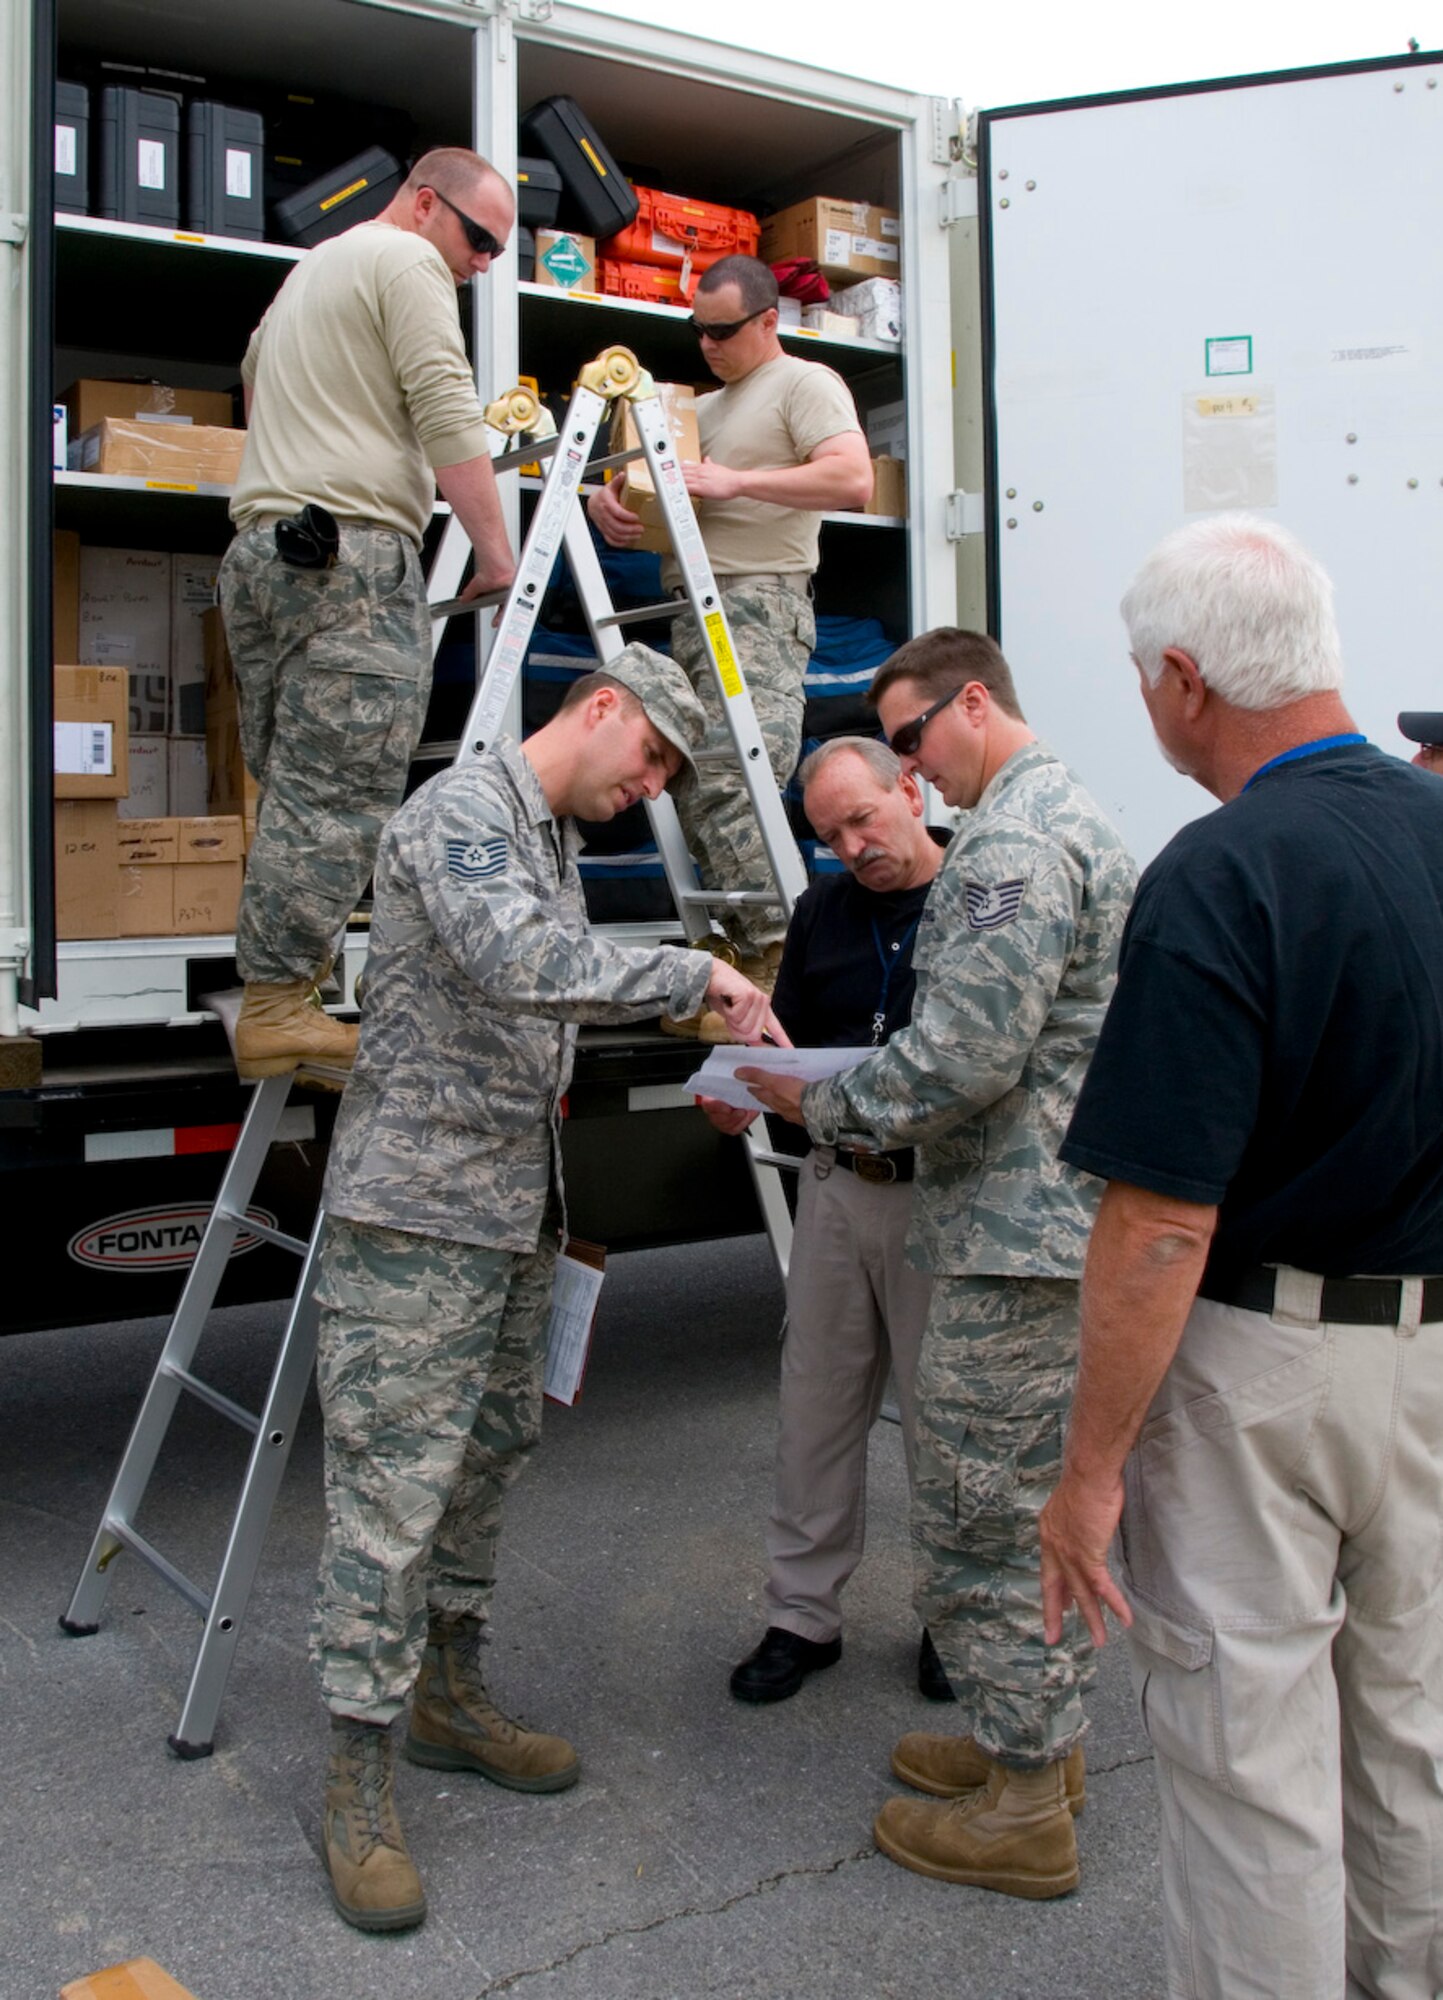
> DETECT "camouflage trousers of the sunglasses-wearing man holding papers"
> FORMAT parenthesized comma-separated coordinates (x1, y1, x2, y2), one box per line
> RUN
(911, 1276, 1095, 1768)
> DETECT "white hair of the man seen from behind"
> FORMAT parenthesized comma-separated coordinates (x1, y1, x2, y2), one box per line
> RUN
(1121, 514, 1343, 708)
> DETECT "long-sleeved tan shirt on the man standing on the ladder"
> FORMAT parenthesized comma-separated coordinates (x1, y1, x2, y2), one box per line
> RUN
(230, 222, 488, 542)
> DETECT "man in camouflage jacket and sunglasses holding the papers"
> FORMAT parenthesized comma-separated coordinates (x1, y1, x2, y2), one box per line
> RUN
(741, 628, 1135, 1898)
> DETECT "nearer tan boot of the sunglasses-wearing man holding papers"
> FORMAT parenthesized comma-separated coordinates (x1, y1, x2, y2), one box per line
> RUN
(871, 1760, 1077, 1902)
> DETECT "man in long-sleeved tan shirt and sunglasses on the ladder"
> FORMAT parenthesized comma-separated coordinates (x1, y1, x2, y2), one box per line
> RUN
(220, 148, 516, 1078)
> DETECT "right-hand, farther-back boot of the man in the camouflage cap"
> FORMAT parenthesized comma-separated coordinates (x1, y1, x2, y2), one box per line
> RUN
(406, 1618, 582, 1792)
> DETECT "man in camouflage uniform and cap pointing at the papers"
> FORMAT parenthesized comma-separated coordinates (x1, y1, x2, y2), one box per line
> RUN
(303, 646, 781, 1930)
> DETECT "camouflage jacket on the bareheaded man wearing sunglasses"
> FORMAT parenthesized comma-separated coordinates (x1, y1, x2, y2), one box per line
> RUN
(801, 742, 1137, 1278)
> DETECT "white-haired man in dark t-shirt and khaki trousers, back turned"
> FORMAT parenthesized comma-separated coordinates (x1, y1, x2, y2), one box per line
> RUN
(1041, 516, 1443, 2000)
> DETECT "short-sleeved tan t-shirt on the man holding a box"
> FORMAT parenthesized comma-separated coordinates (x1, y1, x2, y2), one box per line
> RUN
(662, 354, 861, 588)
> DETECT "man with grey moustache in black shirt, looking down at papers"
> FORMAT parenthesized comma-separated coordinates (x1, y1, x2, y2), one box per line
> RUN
(704, 736, 951, 1702)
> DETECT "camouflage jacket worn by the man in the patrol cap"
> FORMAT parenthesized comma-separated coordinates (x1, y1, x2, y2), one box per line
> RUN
(324, 738, 712, 1252)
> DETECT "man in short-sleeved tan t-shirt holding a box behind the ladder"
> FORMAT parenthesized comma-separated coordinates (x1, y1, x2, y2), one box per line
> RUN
(590, 256, 871, 1040)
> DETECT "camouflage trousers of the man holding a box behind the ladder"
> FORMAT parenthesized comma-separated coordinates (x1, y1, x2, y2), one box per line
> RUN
(674, 576, 817, 956)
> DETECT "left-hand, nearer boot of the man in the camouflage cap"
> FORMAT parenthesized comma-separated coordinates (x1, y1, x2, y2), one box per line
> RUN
(322, 1716, 426, 1930)
